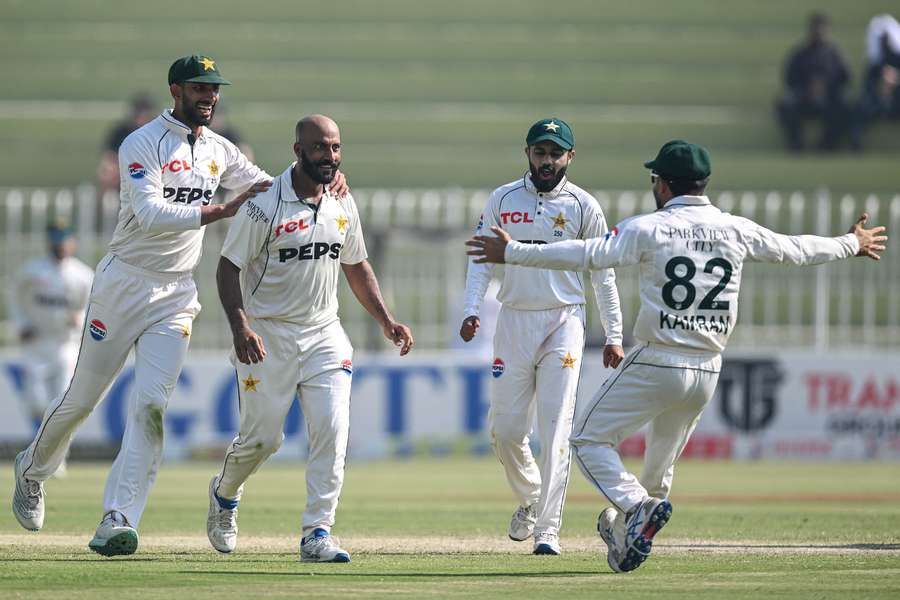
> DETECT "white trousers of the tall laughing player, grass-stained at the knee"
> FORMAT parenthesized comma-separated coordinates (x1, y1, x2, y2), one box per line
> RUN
(22, 255, 200, 527)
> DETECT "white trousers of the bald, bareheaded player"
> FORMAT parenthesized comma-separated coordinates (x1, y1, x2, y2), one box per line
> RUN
(215, 319, 353, 536)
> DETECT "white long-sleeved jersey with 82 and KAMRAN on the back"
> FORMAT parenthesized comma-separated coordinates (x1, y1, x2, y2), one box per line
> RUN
(505, 196, 859, 353)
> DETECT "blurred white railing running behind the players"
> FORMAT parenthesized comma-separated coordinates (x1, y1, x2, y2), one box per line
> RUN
(0, 186, 900, 349)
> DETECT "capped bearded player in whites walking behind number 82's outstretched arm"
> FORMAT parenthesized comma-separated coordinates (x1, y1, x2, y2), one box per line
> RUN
(460, 118, 624, 555)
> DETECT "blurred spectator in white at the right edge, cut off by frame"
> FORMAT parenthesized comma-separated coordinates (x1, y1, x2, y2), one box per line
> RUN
(850, 15, 900, 150)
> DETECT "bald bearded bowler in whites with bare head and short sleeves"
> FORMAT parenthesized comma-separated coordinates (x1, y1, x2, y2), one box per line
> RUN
(207, 115, 413, 562)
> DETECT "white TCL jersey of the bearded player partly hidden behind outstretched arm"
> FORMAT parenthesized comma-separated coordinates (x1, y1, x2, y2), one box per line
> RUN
(463, 173, 622, 344)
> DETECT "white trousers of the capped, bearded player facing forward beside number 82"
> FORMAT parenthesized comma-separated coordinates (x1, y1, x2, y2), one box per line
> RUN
(488, 305, 584, 534)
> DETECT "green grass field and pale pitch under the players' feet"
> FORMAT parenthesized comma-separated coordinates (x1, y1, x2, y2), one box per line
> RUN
(0, 458, 900, 600)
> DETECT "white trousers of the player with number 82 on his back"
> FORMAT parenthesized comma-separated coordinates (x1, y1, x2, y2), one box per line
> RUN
(572, 342, 722, 512)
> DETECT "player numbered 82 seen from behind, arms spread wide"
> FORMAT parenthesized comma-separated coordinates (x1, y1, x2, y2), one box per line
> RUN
(467, 140, 887, 571)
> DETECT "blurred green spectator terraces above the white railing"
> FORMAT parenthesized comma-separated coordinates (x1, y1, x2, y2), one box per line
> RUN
(0, 0, 900, 193)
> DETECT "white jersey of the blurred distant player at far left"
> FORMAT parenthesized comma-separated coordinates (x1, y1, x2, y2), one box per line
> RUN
(10, 256, 94, 343)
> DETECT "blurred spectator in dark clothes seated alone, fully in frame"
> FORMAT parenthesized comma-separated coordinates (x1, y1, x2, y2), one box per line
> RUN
(776, 13, 850, 152)
